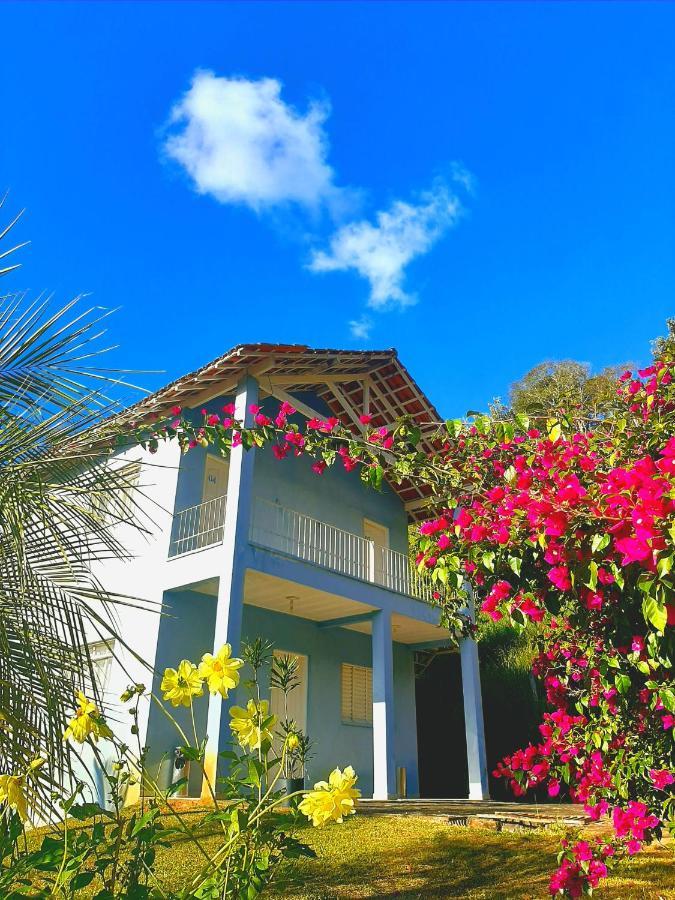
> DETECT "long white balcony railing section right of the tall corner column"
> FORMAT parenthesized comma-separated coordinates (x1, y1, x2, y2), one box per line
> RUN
(251, 498, 433, 601)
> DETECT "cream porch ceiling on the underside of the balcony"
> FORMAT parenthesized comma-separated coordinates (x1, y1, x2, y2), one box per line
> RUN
(244, 570, 448, 644)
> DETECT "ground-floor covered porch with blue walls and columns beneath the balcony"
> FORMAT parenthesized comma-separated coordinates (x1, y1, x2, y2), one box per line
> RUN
(150, 564, 488, 800)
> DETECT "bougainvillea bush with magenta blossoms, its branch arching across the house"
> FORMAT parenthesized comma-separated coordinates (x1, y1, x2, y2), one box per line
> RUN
(139, 358, 675, 897)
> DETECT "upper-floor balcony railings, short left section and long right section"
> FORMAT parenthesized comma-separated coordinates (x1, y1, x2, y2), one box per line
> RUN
(169, 497, 433, 602)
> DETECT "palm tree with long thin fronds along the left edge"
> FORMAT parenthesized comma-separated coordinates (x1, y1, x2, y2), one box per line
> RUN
(0, 201, 151, 808)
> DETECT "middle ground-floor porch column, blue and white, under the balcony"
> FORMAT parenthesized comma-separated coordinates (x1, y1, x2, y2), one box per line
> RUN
(373, 609, 396, 800)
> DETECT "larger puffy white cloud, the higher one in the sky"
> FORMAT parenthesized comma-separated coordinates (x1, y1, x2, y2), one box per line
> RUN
(164, 71, 339, 211)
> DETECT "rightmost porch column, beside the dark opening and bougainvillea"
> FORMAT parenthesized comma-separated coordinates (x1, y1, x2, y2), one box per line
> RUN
(459, 601, 490, 800)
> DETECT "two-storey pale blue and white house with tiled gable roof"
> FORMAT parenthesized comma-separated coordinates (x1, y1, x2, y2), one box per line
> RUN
(88, 344, 488, 799)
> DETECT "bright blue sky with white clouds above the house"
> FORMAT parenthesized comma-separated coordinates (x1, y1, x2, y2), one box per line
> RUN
(0, 2, 675, 415)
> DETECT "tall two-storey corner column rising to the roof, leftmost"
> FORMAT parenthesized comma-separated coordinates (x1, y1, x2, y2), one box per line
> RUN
(202, 376, 258, 797)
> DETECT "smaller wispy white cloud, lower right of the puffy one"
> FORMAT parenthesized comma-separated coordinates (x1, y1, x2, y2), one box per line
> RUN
(309, 180, 461, 310)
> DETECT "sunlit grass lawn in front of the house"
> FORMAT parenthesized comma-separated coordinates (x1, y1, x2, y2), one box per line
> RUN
(148, 816, 675, 900)
